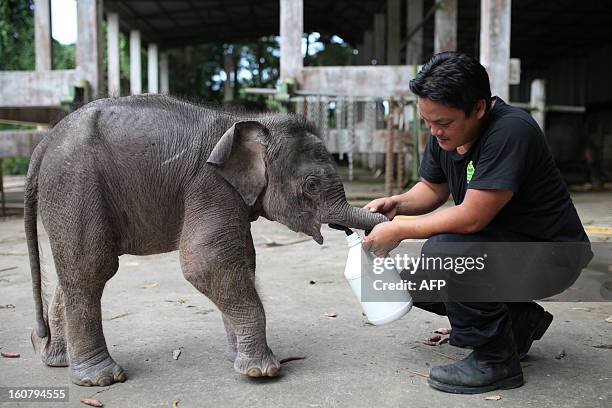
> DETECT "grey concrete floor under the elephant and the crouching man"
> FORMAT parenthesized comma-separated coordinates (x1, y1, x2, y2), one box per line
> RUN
(0, 176, 612, 408)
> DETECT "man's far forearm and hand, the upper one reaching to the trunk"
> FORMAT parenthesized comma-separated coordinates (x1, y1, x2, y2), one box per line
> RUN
(365, 180, 450, 219)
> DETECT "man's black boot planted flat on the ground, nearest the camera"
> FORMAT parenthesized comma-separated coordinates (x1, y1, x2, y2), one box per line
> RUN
(427, 324, 524, 394)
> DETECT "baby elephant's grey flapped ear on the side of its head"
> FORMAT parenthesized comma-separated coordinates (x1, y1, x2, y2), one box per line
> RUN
(206, 121, 268, 206)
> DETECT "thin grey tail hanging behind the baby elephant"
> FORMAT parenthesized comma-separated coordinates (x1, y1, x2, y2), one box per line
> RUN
(23, 135, 49, 338)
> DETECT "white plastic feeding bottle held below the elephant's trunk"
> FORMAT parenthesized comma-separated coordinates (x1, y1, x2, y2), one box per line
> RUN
(344, 231, 412, 326)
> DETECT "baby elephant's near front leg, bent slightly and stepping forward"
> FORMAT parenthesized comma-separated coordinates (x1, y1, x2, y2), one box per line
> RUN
(181, 224, 280, 377)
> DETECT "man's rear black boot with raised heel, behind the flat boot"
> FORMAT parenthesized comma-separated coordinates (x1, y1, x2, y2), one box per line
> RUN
(507, 302, 553, 360)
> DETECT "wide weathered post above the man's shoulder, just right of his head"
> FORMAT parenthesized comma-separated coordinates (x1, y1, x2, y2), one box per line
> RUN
(480, 0, 512, 101)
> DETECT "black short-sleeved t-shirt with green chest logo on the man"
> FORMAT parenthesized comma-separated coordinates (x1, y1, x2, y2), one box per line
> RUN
(420, 97, 588, 241)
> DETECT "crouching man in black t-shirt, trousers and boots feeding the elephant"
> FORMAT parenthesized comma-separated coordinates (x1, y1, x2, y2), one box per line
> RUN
(363, 52, 591, 393)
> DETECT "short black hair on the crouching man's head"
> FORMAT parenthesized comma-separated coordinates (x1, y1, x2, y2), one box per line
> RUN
(409, 51, 491, 116)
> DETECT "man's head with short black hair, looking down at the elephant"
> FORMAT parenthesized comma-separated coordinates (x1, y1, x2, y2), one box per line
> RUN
(410, 52, 491, 151)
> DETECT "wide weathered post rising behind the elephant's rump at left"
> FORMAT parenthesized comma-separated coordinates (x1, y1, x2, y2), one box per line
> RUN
(76, 0, 104, 99)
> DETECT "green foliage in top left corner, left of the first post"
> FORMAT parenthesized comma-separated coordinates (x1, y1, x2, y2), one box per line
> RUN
(0, 0, 35, 71)
